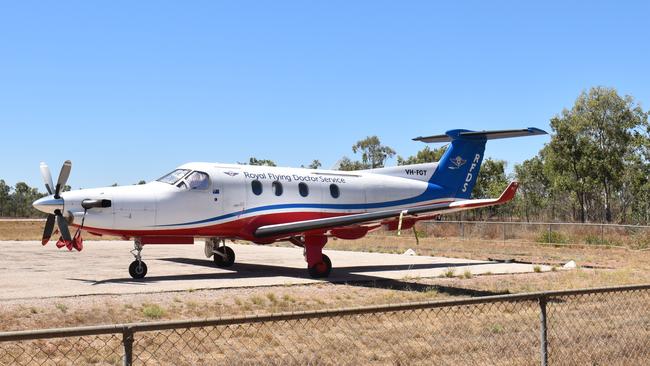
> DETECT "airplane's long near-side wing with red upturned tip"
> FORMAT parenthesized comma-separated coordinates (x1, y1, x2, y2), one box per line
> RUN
(255, 182, 519, 238)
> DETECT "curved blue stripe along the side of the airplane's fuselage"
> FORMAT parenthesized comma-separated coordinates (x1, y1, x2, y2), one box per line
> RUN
(155, 183, 449, 227)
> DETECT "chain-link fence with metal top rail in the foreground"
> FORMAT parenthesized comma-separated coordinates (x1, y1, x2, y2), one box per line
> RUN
(0, 285, 650, 365)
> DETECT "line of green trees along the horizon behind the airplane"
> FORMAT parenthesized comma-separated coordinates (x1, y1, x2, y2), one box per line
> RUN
(0, 87, 650, 224)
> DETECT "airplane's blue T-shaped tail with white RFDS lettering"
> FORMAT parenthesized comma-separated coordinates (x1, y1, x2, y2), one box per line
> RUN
(413, 127, 546, 199)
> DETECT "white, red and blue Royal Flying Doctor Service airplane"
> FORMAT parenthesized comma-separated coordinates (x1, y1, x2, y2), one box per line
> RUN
(33, 127, 547, 279)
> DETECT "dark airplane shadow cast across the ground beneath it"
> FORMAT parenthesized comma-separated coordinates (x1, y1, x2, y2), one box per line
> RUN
(73, 258, 501, 296)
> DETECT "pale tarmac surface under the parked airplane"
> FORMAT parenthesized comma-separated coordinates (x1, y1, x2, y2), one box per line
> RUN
(0, 241, 550, 300)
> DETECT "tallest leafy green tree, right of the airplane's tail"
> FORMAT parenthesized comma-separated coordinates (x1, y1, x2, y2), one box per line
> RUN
(545, 87, 647, 222)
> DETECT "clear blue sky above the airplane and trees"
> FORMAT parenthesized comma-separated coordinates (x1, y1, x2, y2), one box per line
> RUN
(0, 1, 650, 189)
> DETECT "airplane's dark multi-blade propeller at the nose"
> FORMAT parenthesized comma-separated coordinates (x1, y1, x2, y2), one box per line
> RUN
(40, 160, 72, 245)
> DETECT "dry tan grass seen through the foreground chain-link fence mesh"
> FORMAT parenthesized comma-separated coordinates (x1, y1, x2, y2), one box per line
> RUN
(0, 291, 650, 365)
